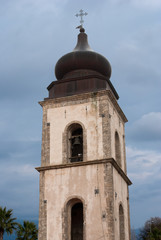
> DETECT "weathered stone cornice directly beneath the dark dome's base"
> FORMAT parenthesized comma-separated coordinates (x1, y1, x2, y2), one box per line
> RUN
(39, 90, 128, 122)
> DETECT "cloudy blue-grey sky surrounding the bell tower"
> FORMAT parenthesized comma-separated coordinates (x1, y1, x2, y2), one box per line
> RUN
(0, 0, 161, 228)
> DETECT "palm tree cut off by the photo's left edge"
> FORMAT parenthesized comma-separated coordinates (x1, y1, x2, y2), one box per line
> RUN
(0, 207, 17, 240)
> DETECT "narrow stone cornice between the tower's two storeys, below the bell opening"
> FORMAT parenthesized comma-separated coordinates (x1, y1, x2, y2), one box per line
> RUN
(36, 158, 132, 185)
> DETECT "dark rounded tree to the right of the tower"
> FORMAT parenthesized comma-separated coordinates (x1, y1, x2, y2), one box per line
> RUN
(139, 217, 161, 240)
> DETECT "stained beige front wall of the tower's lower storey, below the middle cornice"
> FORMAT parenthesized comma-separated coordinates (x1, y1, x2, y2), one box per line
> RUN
(45, 164, 114, 240)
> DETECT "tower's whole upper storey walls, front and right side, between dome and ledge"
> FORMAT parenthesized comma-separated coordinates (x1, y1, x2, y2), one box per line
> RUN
(39, 90, 126, 170)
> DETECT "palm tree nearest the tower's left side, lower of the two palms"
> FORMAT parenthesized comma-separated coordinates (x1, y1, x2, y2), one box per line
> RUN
(16, 221, 38, 240)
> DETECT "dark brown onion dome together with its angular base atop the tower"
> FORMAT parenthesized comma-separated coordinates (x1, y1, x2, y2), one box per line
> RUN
(47, 26, 119, 99)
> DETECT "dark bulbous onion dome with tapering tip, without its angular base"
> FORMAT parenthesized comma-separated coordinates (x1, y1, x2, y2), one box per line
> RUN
(55, 28, 111, 80)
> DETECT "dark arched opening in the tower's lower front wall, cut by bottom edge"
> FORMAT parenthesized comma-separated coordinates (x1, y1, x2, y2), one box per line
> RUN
(71, 202, 83, 240)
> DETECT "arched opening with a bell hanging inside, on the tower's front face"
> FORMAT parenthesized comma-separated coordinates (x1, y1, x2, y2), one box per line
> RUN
(68, 123, 83, 162)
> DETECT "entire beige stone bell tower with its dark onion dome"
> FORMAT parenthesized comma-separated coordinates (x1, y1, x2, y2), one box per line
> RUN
(37, 24, 131, 240)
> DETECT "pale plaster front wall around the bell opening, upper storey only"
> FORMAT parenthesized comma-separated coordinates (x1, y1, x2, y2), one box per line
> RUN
(47, 93, 103, 164)
